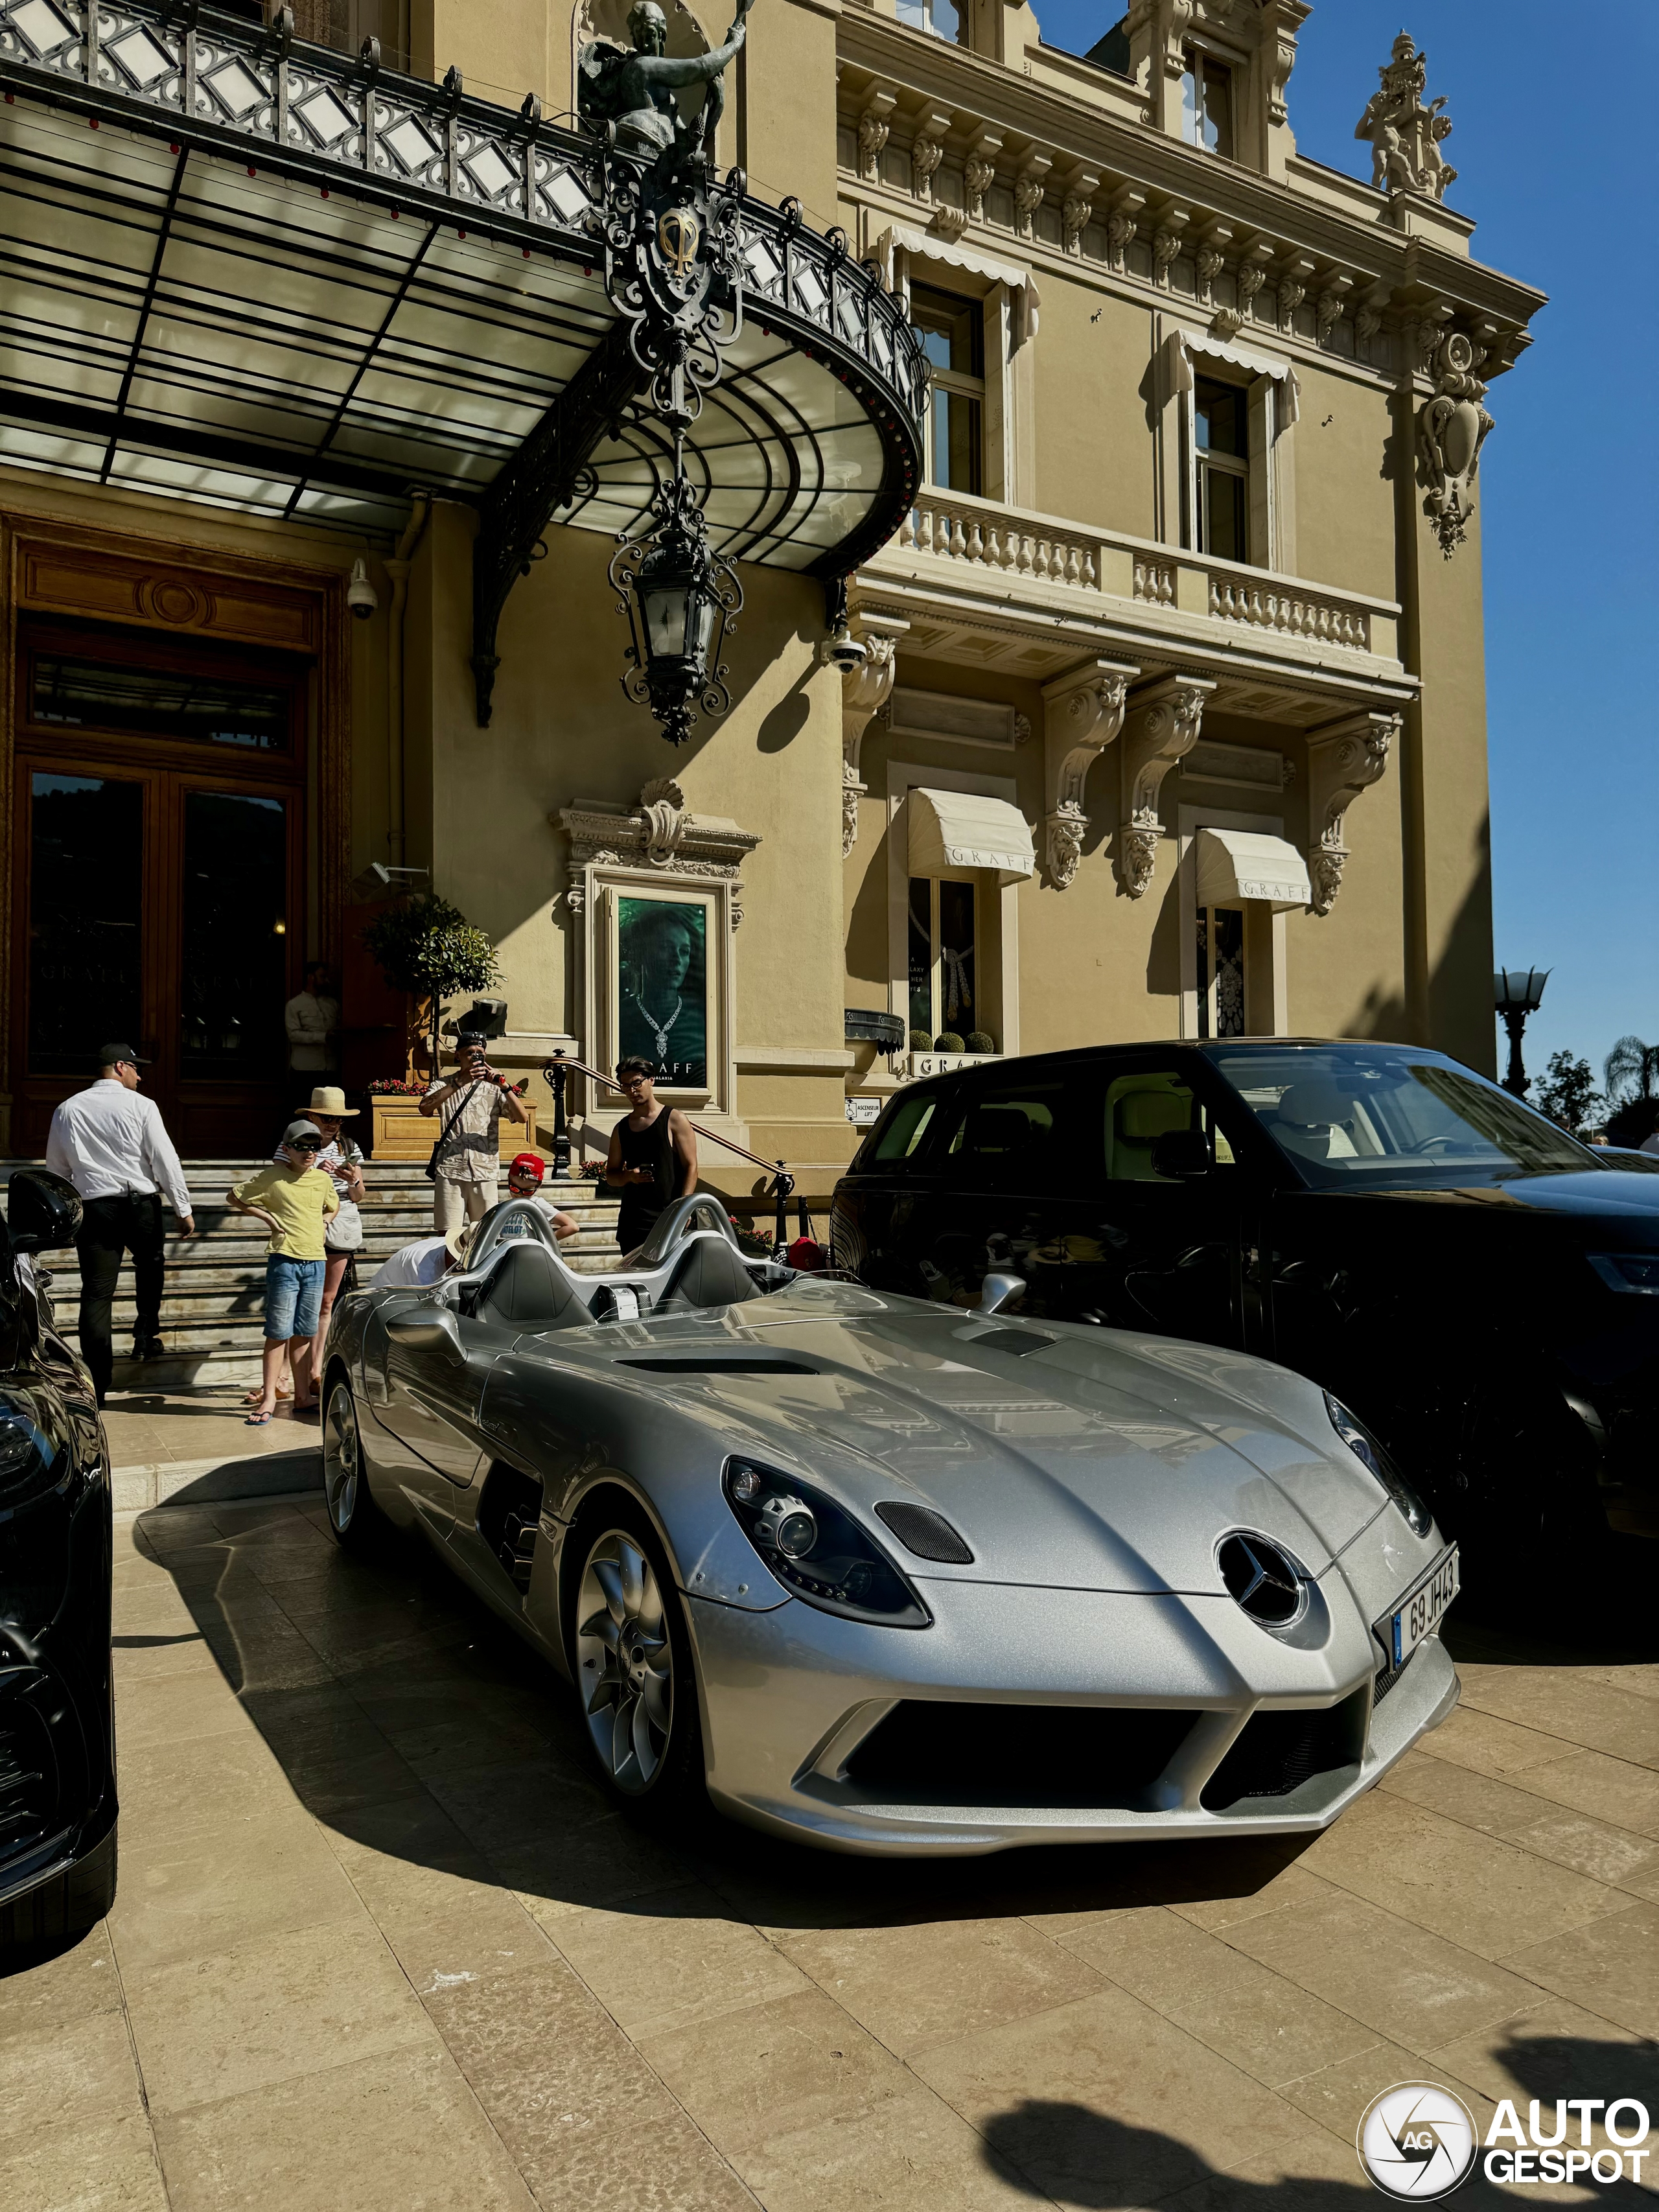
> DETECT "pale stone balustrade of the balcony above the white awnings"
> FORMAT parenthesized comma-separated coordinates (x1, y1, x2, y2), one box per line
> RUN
(876, 487, 1398, 659)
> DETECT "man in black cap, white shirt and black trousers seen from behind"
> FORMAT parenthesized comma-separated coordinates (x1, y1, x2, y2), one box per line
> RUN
(47, 1042, 197, 1404)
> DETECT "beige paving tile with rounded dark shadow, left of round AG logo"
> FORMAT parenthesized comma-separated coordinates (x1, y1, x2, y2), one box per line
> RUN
(911, 1986, 1290, 2206)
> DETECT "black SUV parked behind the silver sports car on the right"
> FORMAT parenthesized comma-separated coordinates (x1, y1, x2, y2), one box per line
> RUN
(831, 1038, 1659, 1548)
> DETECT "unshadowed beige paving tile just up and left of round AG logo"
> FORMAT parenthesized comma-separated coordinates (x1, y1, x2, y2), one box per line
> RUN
(1060, 1905, 1376, 2086)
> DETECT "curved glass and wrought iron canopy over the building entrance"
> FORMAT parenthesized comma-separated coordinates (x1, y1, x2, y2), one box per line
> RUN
(0, 0, 927, 699)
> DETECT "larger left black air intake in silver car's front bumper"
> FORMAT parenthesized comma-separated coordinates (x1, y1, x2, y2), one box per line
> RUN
(847, 1697, 1197, 1810)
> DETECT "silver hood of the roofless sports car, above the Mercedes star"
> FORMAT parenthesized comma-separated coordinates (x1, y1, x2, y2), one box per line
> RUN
(570, 1285, 1385, 1592)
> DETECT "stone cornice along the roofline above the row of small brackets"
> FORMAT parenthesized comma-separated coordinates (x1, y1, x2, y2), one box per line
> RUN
(839, 11, 1544, 345)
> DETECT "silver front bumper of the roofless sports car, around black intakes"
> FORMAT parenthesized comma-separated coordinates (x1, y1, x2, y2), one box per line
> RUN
(688, 1568, 1457, 1856)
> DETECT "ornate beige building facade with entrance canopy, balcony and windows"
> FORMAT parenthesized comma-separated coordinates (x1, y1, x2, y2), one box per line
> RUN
(0, 0, 1542, 1194)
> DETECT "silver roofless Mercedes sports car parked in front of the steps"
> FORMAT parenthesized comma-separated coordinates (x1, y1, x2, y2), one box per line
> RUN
(323, 1199, 1457, 1854)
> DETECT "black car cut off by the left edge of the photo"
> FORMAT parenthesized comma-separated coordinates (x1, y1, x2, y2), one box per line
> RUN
(0, 1168, 115, 1944)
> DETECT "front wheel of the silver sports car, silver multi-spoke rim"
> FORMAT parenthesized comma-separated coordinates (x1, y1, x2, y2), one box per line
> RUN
(571, 1504, 703, 1805)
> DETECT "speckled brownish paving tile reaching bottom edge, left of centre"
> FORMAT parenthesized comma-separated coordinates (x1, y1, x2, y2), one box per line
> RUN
(427, 1958, 748, 2212)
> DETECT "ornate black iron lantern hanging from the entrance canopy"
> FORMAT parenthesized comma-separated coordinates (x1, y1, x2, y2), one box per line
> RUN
(610, 443, 743, 745)
